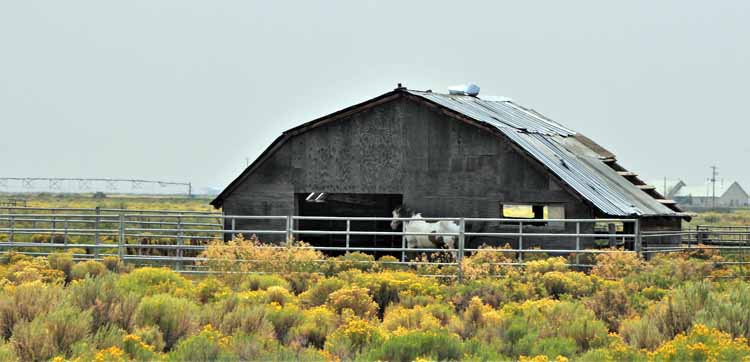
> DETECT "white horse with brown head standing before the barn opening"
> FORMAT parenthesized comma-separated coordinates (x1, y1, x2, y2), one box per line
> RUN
(391, 206, 459, 259)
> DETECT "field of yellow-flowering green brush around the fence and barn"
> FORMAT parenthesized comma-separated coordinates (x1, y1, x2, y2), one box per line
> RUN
(0, 198, 750, 361)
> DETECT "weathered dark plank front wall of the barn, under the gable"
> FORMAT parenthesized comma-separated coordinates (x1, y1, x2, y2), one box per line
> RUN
(223, 98, 594, 246)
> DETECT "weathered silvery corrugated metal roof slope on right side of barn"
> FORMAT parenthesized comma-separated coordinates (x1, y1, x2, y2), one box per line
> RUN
(408, 90, 677, 216)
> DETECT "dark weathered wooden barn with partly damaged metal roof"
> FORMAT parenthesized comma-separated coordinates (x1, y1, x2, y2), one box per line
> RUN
(211, 87, 687, 253)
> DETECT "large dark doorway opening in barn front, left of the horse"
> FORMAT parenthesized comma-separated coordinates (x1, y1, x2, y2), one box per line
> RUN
(295, 193, 403, 258)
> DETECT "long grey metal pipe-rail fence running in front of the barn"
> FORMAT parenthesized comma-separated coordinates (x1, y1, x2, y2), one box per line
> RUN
(0, 207, 750, 273)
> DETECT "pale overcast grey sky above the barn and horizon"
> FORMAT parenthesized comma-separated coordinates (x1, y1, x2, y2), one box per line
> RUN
(0, 0, 750, 194)
